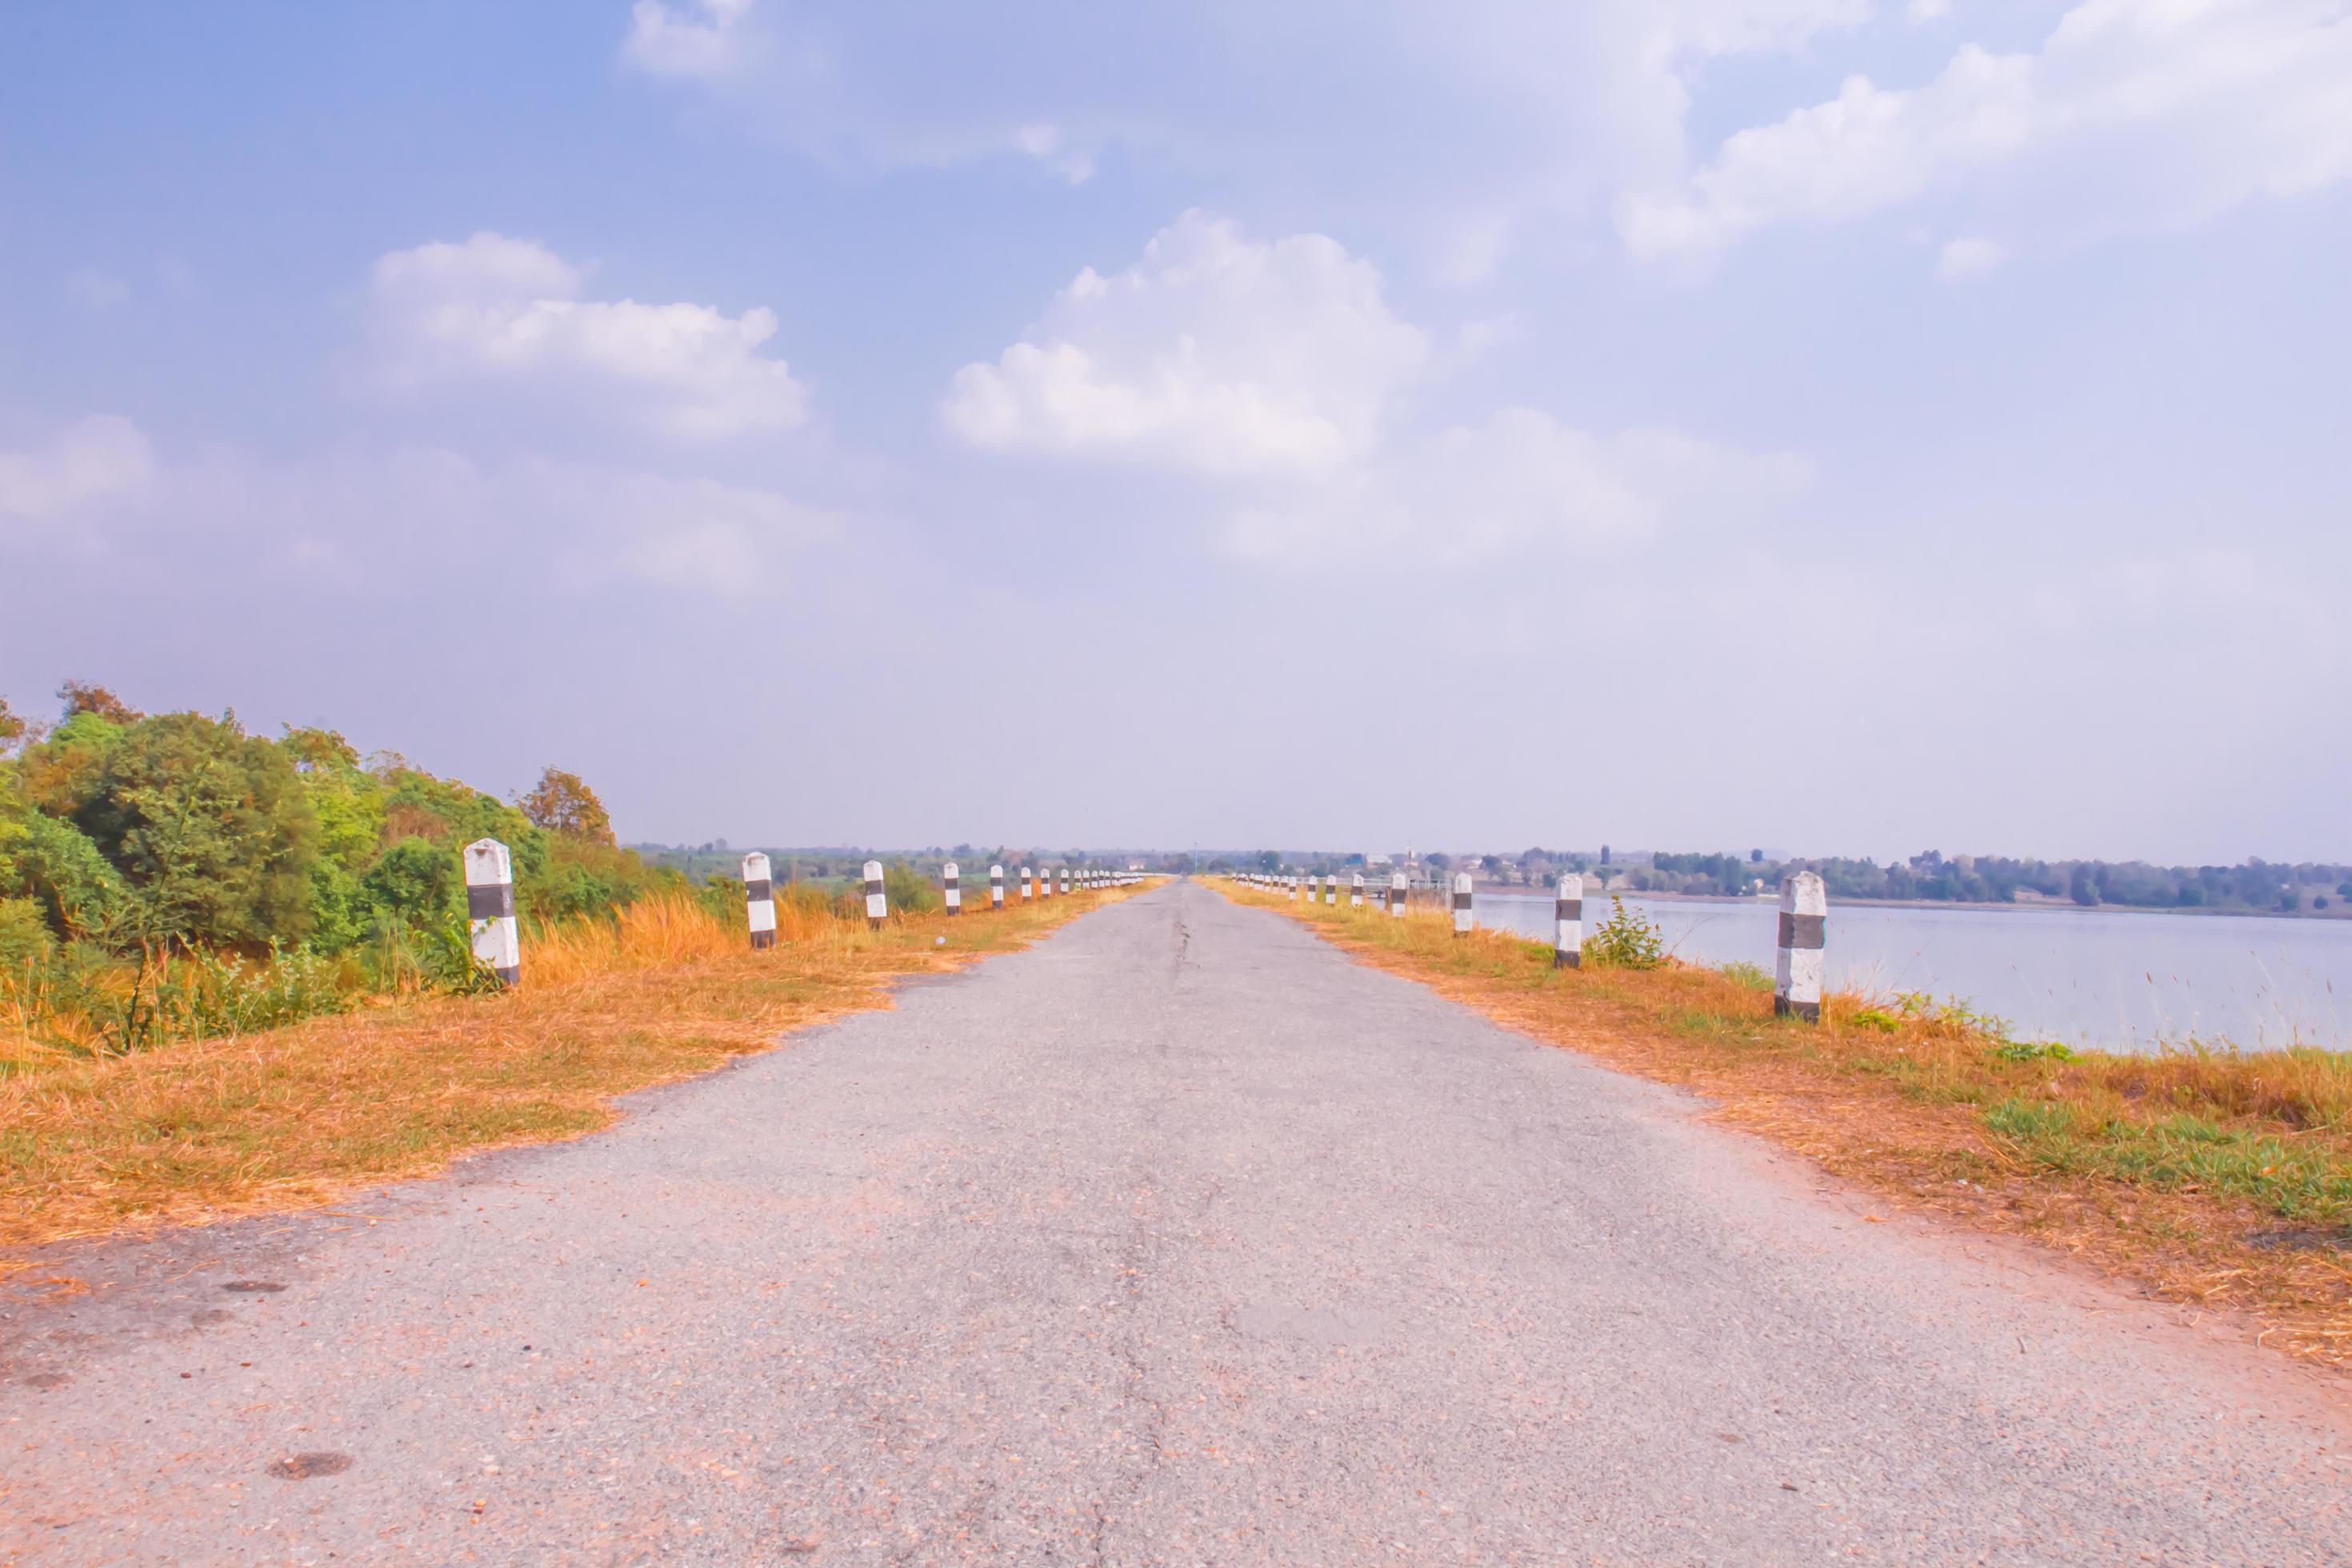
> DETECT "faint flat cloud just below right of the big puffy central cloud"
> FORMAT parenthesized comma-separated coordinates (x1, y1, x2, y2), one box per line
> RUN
(1223, 409, 1809, 566)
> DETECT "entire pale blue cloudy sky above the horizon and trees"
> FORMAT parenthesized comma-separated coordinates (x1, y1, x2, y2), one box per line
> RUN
(0, 0, 2352, 861)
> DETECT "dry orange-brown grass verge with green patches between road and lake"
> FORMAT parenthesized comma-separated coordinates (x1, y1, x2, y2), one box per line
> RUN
(1216, 882, 2352, 1368)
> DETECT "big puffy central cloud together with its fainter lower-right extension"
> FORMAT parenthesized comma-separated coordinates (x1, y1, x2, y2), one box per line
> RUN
(943, 211, 1806, 569)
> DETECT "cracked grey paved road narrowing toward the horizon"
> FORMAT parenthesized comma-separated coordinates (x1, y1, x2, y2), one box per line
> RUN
(0, 886, 2352, 1563)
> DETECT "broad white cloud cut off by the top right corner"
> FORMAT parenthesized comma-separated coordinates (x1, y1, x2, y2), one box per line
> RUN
(1618, 0, 2352, 256)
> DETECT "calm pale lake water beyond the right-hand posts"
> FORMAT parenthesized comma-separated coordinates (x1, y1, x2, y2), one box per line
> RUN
(1477, 894, 2352, 1051)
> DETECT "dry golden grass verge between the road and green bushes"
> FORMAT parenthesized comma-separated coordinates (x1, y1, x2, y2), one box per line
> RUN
(0, 884, 1150, 1274)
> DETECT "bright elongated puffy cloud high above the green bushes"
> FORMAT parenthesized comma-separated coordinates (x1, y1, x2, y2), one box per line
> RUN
(370, 233, 809, 440)
